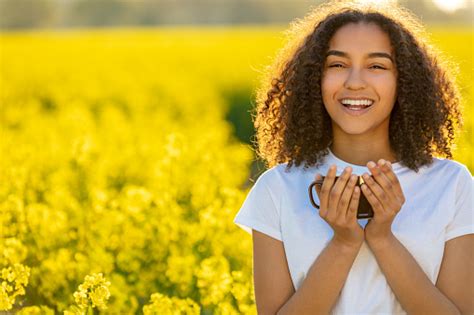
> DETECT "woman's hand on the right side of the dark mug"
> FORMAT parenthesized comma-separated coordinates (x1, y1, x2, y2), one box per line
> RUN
(361, 159, 405, 246)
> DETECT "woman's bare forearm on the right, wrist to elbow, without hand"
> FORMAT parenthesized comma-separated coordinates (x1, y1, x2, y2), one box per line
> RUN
(367, 234, 464, 315)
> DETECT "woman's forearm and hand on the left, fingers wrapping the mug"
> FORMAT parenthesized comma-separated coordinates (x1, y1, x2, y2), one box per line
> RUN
(278, 165, 364, 315)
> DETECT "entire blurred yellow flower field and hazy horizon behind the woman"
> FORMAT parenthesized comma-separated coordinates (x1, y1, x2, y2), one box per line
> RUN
(0, 0, 474, 315)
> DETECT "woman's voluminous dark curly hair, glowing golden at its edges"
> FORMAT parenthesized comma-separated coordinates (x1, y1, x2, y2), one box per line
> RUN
(252, 0, 463, 172)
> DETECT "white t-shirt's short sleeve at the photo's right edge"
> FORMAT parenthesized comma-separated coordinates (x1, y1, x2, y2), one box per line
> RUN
(445, 167, 474, 241)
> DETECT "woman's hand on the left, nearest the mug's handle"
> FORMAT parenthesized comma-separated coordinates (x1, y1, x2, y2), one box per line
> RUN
(316, 165, 364, 247)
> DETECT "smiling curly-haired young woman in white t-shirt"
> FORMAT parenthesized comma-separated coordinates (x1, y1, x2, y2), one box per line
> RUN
(234, 1, 474, 314)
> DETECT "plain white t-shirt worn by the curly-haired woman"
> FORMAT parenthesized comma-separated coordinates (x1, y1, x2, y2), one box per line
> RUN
(233, 151, 474, 314)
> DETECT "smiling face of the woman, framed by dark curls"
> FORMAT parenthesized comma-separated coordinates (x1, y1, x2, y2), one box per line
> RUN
(321, 23, 397, 139)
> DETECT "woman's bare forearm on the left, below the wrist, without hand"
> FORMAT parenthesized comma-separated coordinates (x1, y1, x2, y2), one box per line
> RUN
(277, 238, 362, 315)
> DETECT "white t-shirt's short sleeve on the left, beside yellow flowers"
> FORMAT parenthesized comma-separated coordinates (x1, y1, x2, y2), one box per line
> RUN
(233, 170, 282, 241)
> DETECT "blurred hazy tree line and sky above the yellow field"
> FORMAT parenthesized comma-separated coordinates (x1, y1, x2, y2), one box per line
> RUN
(0, 0, 474, 29)
